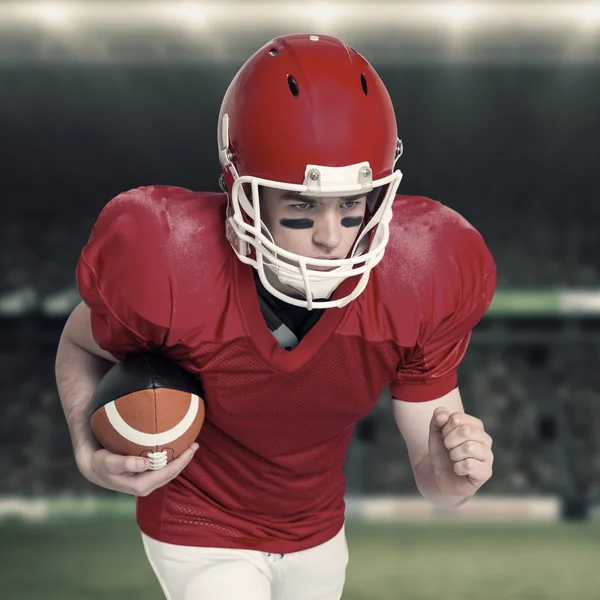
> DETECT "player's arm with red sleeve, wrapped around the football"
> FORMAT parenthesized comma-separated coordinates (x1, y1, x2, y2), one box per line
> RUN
(55, 190, 197, 496)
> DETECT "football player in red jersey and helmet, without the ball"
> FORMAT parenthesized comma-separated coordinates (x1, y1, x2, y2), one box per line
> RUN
(56, 35, 496, 600)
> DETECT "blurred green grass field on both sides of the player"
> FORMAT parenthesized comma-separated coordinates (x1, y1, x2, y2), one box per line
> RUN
(0, 518, 600, 600)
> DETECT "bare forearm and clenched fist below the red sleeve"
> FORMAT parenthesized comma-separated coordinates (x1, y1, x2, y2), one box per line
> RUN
(393, 388, 494, 507)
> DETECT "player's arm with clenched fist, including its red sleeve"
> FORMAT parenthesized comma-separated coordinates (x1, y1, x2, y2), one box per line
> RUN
(390, 214, 496, 506)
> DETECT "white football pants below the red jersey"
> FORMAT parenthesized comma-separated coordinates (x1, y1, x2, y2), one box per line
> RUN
(142, 527, 348, 600)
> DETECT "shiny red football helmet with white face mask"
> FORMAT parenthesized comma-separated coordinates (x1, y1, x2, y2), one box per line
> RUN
(218, 35, 402, 309)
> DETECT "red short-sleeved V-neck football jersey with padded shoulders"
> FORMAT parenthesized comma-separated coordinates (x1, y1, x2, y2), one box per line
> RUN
(77, 186, 496, 554)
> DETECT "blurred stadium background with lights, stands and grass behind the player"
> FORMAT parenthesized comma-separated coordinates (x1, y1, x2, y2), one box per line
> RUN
(0, 0, 600, 600)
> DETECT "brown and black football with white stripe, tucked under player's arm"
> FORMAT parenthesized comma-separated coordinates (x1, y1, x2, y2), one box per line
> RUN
(91, 354, 205, 470)
